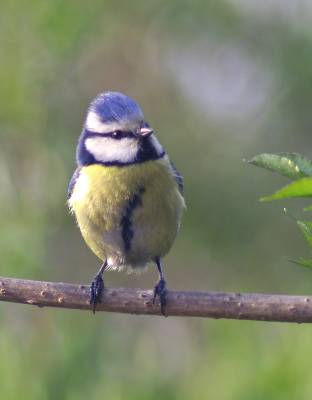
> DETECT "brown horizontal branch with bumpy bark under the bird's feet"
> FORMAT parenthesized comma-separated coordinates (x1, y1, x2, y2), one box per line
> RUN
(0, 277, 312, 323)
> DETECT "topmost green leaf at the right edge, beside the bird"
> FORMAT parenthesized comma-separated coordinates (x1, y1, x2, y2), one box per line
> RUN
(248, 153, 312, 180)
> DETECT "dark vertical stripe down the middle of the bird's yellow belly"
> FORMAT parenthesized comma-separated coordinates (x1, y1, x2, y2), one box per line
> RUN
(120, 186, 145, 253)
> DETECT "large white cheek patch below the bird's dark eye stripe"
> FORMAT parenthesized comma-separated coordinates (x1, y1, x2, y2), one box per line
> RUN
(85, 137, 139, 163)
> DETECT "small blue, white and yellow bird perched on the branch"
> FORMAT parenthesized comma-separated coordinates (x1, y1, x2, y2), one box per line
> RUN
(67, 91, 185, 315)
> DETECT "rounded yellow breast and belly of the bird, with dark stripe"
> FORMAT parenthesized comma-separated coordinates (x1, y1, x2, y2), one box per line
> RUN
(69, 157, 184, 268)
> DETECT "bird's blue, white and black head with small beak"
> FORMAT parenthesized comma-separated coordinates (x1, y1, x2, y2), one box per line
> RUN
(77, 92, 165, 166)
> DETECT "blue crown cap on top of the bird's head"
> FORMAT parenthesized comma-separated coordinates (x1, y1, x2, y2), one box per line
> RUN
(89, 92, 143, 122)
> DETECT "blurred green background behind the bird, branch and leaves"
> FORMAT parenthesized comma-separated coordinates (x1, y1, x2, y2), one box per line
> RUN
(0, 0, 312, 400)
